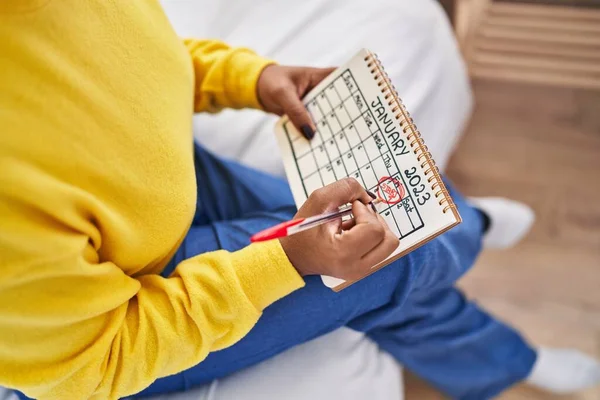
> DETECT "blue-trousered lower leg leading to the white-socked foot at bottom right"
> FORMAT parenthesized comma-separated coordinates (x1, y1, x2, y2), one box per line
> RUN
(368, 287, 536, 400)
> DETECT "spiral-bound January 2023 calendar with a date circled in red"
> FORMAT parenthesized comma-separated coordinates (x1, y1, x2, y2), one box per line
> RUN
(275, 50, 461, 290)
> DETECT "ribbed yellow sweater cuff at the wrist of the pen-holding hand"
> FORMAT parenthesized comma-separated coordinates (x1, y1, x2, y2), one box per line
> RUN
(231, 240, 304, 311)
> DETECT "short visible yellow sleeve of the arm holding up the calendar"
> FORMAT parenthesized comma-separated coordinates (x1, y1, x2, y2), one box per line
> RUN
(184, 39, 274, 112)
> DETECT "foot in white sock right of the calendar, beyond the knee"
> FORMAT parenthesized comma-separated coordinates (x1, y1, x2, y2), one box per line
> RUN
(469, 197, 535, 249)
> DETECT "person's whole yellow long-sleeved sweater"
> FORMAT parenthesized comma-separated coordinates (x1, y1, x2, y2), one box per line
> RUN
(0, 0, 303, 400)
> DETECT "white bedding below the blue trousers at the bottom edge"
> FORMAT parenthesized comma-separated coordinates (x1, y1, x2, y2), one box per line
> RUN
(141, 328, 404, 400)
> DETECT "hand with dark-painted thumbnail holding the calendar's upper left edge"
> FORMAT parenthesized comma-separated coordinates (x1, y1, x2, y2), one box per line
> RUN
(256, 65, 335, 140)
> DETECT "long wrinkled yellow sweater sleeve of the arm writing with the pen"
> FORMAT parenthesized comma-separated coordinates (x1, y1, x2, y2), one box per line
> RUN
(0, 196, 304, 400)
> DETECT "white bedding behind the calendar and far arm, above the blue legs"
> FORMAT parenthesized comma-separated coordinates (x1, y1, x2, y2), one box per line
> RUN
(163, 0, 472, 176)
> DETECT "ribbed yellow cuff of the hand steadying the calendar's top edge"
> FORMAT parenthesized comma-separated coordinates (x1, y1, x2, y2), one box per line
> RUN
(230, 49, 276, 110)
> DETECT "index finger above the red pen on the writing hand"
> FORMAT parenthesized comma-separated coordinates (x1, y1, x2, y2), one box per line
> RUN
(309, 178, 373, 213)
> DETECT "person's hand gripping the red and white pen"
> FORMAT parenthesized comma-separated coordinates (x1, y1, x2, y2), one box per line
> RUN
(279, 178, 399, 280)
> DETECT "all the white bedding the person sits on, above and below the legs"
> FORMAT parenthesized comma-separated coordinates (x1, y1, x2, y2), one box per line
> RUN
(0, 0, 471, 400)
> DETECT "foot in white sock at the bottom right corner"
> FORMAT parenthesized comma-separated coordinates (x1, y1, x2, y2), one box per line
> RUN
(527, 347, 600, 394)
